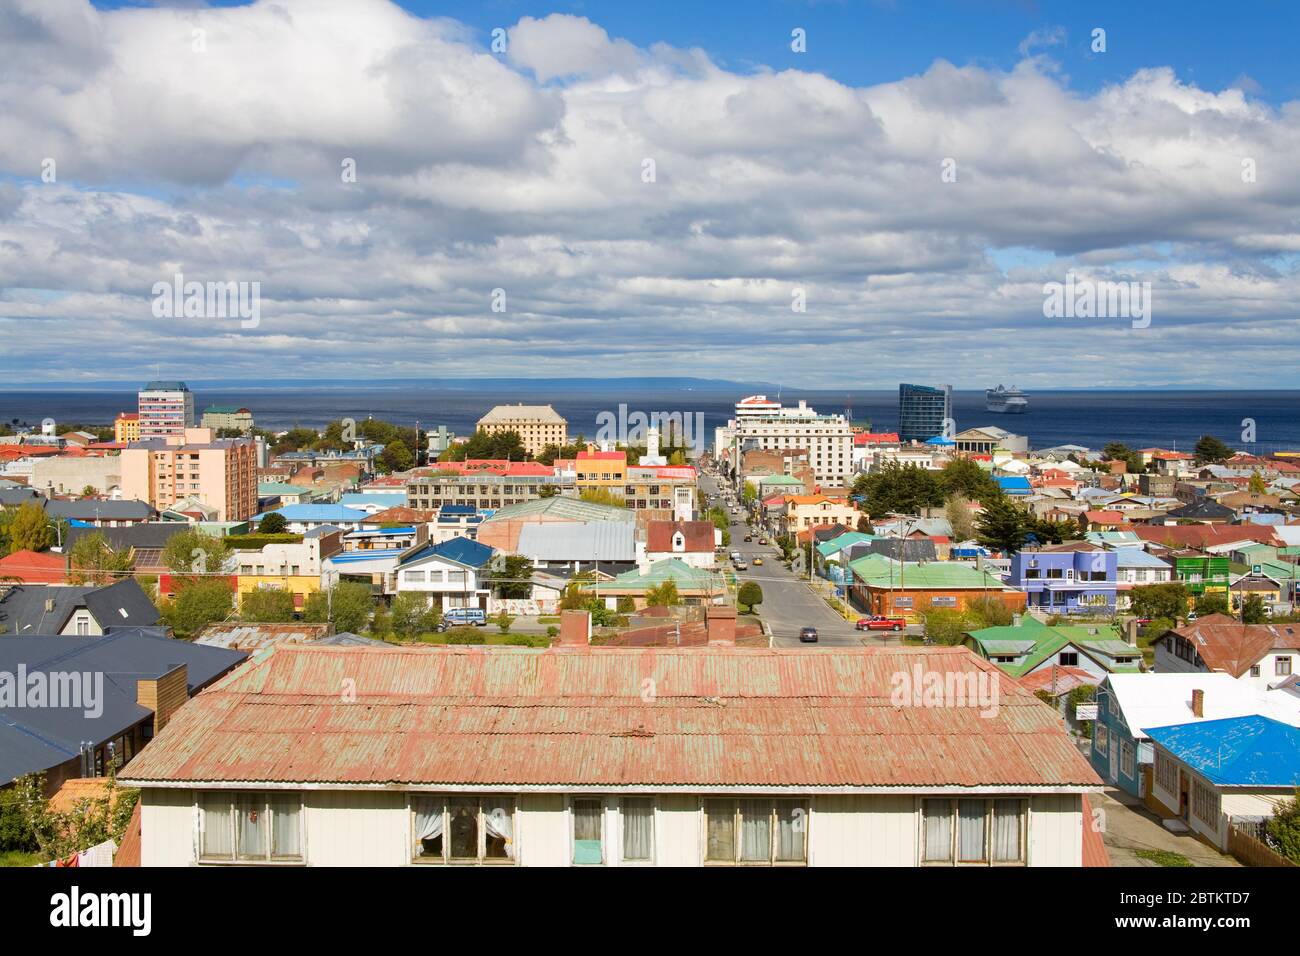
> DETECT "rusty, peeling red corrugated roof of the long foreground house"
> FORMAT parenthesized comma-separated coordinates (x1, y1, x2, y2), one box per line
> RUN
(122, 645, 1101, 791)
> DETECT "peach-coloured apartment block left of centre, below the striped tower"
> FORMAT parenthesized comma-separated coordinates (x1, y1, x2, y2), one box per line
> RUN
(120, 428, 257, 522)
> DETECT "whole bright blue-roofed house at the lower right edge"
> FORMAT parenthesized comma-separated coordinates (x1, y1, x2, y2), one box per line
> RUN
(1147, 714, 1300, 852)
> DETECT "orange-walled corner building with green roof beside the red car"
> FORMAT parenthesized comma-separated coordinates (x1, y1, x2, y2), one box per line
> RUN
(849, 554, 1026, 622)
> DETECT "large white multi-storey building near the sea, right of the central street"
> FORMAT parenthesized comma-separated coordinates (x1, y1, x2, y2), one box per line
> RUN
(715, 395, 853, 488)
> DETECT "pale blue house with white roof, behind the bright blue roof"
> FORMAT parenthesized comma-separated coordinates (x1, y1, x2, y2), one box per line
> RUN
(1089, 672, 1300, 799)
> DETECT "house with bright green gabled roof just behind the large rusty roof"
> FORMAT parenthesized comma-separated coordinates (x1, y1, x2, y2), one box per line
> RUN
(963, 617, 1141, 682)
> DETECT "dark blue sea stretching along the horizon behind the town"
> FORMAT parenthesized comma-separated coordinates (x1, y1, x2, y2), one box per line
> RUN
(0, 380, 1300, 453)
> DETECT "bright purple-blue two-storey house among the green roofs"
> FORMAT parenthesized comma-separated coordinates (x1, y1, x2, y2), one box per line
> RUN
(1006, 541, 1118, 614)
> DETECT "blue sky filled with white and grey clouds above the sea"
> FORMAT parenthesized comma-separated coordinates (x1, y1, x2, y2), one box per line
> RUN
(0, 0, 1300, 389)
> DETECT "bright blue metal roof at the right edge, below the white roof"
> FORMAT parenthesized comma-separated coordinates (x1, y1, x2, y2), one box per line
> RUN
(1145, 714, 1300, 787)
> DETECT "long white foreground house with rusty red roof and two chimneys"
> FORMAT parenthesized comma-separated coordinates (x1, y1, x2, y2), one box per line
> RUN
(121, 632, 1101, 866)
